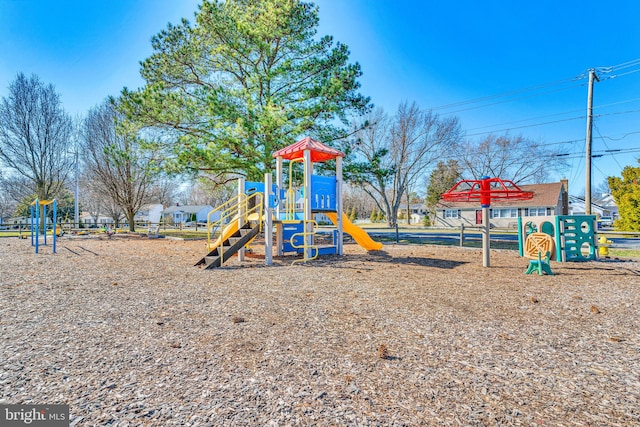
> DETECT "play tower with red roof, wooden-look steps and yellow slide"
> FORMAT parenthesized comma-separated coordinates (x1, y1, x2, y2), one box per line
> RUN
(196, 137, 382, 268)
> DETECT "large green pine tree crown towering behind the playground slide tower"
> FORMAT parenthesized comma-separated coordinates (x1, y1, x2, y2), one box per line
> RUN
(122, 0, 369, 180)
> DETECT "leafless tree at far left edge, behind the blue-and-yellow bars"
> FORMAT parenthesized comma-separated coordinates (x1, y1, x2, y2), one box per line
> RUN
(0, 73, 73, 199)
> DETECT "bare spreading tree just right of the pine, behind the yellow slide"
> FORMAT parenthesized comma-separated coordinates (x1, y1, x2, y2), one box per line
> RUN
(345, 102, 461, 227)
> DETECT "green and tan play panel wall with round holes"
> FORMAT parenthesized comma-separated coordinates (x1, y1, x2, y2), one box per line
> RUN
(518, 215, 598, 262)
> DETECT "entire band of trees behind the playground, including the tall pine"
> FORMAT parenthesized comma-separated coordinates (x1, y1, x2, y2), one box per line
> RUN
(0, 0, 639, 231)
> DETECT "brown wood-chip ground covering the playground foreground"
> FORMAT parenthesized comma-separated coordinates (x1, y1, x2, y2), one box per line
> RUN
(0, 236, 640, 426)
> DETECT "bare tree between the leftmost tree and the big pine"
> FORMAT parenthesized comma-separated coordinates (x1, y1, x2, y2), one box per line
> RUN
(83, 101, 156, 232)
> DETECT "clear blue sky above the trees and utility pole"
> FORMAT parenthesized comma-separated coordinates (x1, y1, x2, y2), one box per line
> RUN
(0, 0, 640, 194)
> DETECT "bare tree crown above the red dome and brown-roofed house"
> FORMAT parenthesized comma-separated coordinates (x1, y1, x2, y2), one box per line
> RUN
(452, 135, 565, 184)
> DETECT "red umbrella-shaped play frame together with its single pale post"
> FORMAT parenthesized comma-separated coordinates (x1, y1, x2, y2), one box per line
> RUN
(442, 176, 533, 267)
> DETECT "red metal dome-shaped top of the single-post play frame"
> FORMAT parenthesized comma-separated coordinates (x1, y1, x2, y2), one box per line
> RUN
(442, 177, 533, 208)
